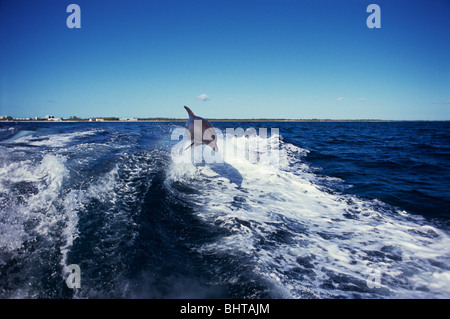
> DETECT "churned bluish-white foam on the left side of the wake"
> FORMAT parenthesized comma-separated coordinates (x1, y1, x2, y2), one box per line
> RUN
(0, 124, 162, 298)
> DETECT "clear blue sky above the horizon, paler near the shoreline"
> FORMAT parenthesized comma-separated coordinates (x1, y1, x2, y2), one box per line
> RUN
(0, 0, 450, 120)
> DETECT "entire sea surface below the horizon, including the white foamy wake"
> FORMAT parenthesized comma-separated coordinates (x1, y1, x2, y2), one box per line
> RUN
(0, 122, 450, 298)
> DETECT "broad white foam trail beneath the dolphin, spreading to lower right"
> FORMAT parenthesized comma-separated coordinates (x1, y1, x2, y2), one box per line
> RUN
(168, 137, 450, 298)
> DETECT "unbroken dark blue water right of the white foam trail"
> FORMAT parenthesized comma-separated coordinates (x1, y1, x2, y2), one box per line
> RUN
(283, 122, 450, 224)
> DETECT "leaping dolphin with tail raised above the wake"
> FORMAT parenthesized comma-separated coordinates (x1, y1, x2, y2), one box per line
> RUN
(184, 106, 219, 152)
